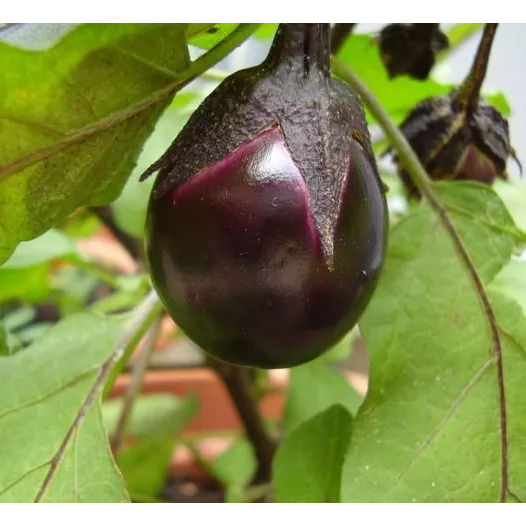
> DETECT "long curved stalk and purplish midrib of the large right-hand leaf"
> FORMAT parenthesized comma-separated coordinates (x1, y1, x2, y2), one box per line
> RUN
(333, 58, 509, 502)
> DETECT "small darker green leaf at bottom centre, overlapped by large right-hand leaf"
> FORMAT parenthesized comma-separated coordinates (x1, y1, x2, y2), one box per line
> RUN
(273, 405, 352, 504)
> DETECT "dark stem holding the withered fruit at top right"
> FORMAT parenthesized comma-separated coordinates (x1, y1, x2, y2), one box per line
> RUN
(455, 22, 498, 109)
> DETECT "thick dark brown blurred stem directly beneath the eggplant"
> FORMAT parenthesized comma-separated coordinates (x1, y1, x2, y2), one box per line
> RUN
(207, 357, 276, 485)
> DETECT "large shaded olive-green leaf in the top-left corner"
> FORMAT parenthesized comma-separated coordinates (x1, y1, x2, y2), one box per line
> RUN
(0, 22, 189, 262)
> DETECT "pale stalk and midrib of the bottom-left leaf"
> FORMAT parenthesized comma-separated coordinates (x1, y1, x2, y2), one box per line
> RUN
(34, 291, 160, 504)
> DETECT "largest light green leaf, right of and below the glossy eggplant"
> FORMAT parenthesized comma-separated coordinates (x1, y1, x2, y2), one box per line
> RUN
(342, 182, 526, 503)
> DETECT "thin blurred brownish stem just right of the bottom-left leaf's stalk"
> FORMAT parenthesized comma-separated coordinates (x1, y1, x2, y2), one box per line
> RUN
(111, 316, 161, 456)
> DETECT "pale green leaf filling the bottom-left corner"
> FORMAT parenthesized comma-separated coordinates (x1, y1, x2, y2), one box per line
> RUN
(0, 313, 128, 503)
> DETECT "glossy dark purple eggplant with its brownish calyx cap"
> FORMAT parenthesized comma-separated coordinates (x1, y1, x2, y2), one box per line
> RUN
(145, 24, 388, 369)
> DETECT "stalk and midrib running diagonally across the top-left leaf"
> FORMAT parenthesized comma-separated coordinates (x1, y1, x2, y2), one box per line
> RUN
(0, 22, 261, 182)
